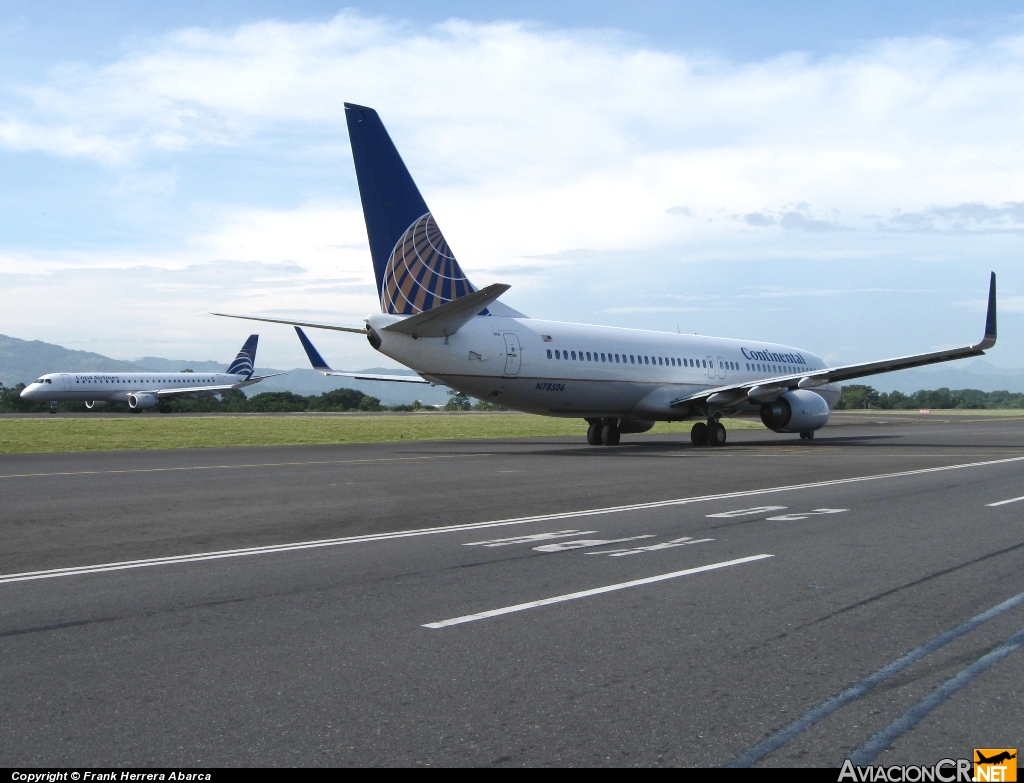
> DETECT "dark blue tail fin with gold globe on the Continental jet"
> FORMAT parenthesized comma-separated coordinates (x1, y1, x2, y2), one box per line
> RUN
(345, 103, 476, 315)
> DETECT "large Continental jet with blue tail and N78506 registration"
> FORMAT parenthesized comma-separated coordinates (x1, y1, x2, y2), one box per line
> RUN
(215, 103, 995, 445)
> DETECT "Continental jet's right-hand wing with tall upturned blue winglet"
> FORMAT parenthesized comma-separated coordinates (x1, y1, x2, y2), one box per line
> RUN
(670, 272, 995, 408)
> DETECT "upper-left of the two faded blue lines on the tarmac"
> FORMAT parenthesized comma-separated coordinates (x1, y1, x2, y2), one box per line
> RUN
(725, 593, 1024, 767)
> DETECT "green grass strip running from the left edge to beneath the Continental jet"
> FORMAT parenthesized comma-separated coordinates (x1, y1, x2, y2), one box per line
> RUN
(0, 412, 761, 453)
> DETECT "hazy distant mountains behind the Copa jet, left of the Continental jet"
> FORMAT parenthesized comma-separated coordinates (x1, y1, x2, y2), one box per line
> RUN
(0, 335, 447, 405)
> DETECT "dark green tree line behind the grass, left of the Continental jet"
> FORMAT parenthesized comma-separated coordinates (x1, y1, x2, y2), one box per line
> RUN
(0, 384, 506, 414)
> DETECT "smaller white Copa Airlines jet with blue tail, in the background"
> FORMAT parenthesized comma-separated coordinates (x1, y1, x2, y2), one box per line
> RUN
(22, 335, 281, 414)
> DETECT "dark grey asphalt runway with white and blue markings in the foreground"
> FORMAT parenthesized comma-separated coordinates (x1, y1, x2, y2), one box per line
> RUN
(0, 415, 1024, 767)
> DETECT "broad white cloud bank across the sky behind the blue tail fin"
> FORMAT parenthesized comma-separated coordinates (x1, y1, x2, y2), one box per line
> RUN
(0, 11, 1024, 365)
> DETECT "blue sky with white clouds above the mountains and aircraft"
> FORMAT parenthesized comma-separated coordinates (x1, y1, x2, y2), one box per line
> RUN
(0, 0, 1024, 368)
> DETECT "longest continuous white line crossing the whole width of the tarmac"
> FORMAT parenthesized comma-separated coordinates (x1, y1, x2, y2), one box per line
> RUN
(0, 456, 1024, 584)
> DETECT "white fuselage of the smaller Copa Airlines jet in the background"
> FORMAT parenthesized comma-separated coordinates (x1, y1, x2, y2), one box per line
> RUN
(22, 373, 247, 402)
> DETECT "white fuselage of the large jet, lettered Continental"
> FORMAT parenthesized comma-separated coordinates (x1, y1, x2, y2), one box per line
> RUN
(367, 313, 841, 421)
